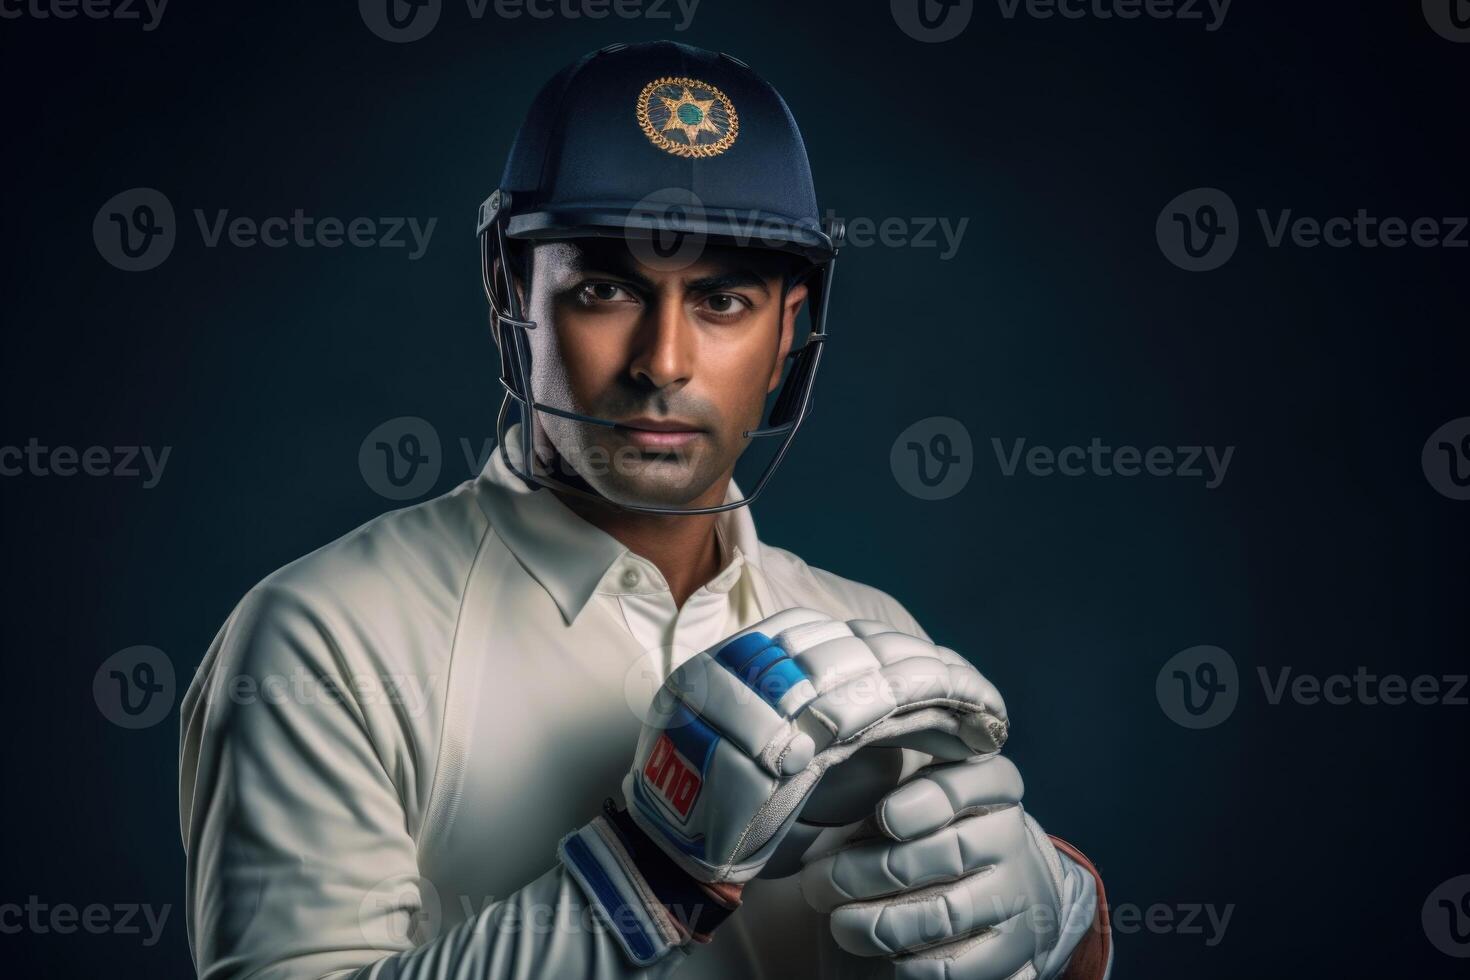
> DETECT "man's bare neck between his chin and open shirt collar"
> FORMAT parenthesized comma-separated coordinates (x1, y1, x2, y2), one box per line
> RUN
(557, 492, 723, 608)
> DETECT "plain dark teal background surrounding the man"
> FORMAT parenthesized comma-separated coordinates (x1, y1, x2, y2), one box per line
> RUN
(0, 0, 1470, 979)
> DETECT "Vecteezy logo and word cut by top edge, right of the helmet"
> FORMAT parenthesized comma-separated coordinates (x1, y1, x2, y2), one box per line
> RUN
(888, 0, 1232, 44)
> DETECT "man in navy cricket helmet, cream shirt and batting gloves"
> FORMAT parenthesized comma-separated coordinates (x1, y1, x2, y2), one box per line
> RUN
(179, 43, 1110, 980)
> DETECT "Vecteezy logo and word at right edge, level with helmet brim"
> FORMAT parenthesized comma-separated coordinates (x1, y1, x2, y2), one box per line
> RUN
(1154, 187, 1470, 272)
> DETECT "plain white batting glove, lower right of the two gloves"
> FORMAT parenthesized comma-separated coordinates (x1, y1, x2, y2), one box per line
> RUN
(801, 754, 1097, 980)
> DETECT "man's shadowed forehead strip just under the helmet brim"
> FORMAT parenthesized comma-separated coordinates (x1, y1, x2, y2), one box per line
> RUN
(532, 238, 792, 282)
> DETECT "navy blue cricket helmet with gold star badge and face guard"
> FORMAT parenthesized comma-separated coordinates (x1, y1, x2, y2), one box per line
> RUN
(478, 41, 842, 514)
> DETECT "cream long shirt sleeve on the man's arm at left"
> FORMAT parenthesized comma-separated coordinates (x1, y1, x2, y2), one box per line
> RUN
(179, 586, 688, 980)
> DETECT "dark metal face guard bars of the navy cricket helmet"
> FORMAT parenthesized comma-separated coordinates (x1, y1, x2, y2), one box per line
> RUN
(479, 205, 842, 514)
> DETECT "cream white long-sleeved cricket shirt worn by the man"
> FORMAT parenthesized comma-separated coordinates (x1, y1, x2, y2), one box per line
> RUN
(179, 429, 925, 980)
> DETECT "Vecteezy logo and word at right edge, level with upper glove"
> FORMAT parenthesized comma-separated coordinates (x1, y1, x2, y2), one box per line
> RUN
(1154, 646, 1470, 729)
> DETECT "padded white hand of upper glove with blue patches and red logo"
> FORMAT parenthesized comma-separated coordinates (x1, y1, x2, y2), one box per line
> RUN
(623, 608, 1007, 883)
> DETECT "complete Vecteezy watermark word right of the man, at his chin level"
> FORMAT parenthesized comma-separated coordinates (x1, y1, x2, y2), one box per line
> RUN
(991, 436, 1235, 489)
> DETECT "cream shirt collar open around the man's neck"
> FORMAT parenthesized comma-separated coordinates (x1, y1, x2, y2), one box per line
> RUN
(478, 422, 760, 623)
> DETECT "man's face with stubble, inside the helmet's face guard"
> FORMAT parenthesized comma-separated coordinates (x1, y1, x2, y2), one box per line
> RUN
(529, 238, 807, 507)
